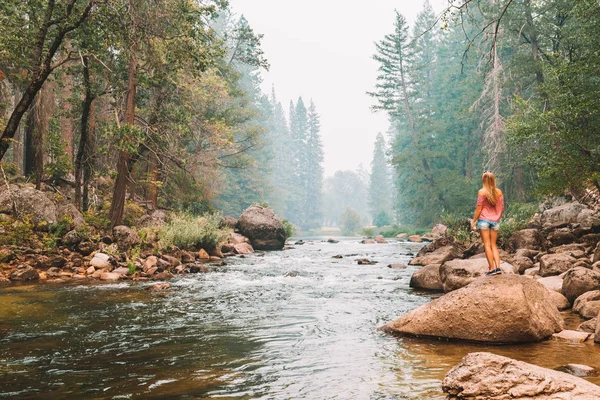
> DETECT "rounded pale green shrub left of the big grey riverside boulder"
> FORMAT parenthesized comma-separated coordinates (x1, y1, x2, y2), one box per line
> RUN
(158, 213, 228, 251)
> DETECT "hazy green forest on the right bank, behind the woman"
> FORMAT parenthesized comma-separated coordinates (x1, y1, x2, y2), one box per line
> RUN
(370, 0, 600, 226)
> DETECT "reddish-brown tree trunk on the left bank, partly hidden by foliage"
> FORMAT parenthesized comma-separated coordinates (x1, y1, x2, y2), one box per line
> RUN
(110, 48, 137, 229)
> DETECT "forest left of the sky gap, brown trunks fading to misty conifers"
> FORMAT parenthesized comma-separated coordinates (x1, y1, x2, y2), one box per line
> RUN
(0, 0, 323, 228)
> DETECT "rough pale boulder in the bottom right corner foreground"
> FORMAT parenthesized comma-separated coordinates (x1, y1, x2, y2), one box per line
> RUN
(442, 352, 600, 400)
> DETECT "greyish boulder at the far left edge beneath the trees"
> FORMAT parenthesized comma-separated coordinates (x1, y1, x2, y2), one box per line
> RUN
(0, 185, 58, 225)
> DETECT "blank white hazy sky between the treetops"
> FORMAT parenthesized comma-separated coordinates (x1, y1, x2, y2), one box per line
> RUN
(230, 0, 446, 176)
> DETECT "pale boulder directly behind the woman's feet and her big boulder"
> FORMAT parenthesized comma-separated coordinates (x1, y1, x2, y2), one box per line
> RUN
(440, 258, 515, 293)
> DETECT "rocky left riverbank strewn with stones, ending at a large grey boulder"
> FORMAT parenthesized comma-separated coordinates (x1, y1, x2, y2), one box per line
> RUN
(0, 184, 286, 287)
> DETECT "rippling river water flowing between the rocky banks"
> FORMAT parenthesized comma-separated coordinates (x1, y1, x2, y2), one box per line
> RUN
(0, 239, 600, 399)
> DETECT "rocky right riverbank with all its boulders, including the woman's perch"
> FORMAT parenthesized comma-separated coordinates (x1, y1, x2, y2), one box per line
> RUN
(381, 202, 600, 400)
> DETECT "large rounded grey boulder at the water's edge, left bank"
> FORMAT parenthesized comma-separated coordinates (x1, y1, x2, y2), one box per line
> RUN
(238, 206, 285, 250)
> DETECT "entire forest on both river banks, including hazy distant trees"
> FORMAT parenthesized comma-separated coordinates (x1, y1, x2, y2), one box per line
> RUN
(0, 0, 600, 230)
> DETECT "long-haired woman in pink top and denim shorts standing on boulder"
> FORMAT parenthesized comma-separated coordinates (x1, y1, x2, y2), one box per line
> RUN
(471, 171, 504, 275)
